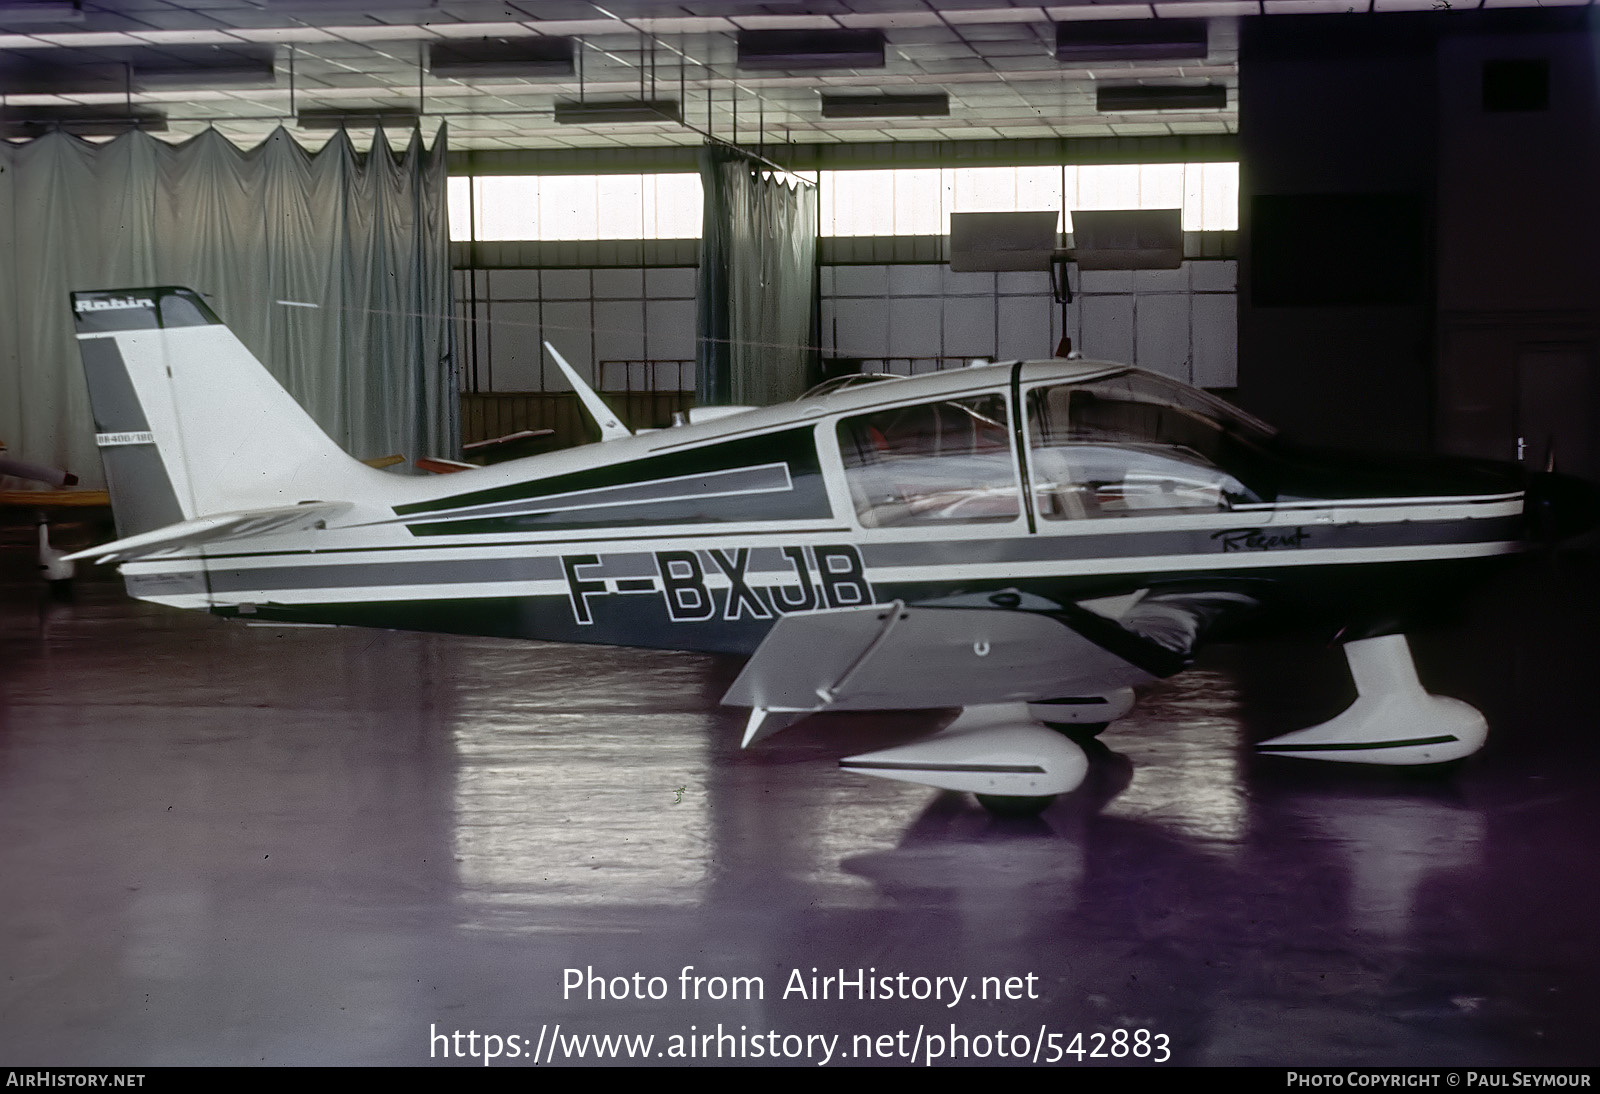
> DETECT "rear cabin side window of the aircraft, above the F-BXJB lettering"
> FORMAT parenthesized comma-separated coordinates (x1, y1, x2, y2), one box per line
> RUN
(838, 393, 1021, 528)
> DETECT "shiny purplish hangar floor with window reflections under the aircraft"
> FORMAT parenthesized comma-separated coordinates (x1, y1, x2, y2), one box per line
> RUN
(0, 528, 1600, 1067)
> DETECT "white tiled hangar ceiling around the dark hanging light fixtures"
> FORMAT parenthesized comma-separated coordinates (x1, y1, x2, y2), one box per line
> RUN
(0, 0, 1273, 149)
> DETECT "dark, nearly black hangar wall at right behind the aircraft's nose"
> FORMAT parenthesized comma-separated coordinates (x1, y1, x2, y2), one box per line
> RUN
(1238, 8, 1600, 477)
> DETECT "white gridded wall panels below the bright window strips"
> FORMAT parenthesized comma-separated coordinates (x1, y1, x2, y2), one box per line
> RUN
(456, 259, 1237, 441)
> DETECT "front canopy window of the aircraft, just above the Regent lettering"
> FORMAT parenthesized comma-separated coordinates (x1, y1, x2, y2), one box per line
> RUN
(1027, 376, 1254, 520)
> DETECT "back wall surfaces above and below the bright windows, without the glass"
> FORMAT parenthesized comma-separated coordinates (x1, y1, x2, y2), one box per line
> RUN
(453, 136, 1237, 440)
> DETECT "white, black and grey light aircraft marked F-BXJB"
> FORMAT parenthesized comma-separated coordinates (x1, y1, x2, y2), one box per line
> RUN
(59, 288, 1587, 811)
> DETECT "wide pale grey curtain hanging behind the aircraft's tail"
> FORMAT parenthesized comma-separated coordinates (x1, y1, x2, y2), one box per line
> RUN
(0, 128, 461, 485)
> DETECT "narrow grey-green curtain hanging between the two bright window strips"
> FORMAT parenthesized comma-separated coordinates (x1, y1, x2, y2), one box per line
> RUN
(694, 144, 816, 406)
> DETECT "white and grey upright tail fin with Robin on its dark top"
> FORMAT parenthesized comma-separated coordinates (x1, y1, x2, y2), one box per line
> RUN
(72, 286, 394, 537)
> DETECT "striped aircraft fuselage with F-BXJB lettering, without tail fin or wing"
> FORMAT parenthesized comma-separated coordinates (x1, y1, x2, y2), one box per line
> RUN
(123, 361, 1525, 654)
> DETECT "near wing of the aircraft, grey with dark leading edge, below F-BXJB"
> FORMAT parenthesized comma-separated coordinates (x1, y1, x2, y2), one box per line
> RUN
(723, 590, 1256, 745)
